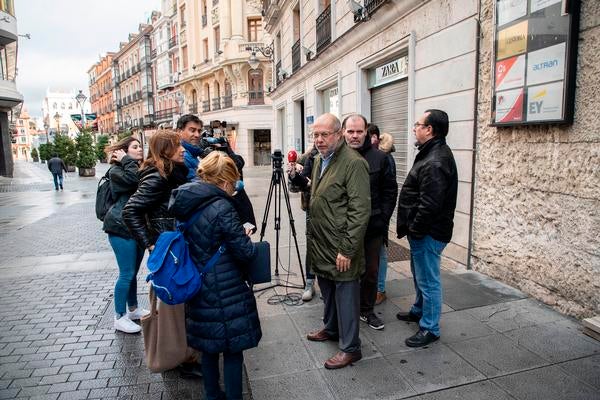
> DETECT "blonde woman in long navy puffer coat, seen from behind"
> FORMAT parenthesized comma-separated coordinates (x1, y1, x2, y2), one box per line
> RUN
(169, 151, 262, 400)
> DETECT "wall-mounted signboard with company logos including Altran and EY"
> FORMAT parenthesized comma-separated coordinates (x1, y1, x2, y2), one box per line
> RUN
(492, 0, 580, 126)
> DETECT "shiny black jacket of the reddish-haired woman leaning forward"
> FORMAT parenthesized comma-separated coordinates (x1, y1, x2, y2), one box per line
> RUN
(122, 164, 187, 248)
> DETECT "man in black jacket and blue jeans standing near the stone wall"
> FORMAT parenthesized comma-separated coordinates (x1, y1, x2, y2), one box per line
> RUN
(397, 110, 458, 347)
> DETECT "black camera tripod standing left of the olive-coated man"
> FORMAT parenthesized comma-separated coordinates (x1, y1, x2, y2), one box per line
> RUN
(260, 150, 306, 290)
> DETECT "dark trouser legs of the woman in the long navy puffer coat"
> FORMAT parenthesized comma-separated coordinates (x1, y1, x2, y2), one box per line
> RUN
(202, 351, 244, 400)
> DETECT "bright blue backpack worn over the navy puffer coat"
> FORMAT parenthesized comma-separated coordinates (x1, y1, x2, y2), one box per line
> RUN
(146, 208, 225, 305)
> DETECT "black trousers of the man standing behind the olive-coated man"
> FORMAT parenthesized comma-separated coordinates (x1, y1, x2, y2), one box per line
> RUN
(360, 235, 383, 315)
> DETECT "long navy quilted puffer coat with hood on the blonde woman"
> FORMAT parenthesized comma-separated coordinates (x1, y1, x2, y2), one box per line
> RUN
(169, 181, 262, 353)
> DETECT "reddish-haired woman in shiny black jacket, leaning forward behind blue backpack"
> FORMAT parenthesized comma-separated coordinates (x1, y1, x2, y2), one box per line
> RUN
(123, 130, 202, 378)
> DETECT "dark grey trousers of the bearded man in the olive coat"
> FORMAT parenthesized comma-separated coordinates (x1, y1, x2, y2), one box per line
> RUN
(317, 276, 360, 353)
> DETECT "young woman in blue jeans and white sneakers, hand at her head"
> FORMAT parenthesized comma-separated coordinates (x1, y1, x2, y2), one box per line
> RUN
(102, 136, 150, 333)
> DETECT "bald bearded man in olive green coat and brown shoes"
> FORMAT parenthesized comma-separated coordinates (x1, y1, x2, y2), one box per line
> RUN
(306, 114, 371, 369)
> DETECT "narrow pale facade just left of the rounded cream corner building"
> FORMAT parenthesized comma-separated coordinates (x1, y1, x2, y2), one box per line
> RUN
(152, 0, 185, 127)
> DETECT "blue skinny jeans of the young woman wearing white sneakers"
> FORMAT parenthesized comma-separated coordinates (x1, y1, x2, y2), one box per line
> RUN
(108, 234, 144, 317)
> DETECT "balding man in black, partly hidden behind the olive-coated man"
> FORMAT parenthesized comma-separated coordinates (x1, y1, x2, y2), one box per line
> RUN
(342, 114, 398, 330)
